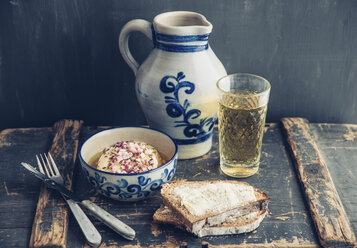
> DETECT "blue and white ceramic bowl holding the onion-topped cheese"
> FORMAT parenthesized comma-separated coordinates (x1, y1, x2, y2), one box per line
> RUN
(79, 127, 177, 201)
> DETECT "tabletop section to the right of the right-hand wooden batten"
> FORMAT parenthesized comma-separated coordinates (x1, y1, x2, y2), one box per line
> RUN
(309, 123, 357, 242)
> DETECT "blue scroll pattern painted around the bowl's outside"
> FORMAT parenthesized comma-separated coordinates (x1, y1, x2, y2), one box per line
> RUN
(82, 161, 177, 199)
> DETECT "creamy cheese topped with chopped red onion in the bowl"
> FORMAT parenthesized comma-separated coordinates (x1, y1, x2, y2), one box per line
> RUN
(89, 140, 167, 174)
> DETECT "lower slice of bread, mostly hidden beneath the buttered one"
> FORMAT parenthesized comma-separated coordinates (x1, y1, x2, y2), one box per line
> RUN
(153, 205, 267, 237)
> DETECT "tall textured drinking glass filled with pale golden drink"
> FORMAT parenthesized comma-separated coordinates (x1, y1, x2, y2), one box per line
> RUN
(217, 73, 270, 178)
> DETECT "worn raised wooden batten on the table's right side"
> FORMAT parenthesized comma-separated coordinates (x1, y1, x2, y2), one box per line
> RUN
(281, 118, 357, 247)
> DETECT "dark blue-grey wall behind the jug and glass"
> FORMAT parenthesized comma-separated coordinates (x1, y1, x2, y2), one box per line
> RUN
(0, 0, 357, 130)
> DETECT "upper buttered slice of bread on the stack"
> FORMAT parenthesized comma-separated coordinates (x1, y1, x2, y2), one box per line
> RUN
(161, 180, 269, 233)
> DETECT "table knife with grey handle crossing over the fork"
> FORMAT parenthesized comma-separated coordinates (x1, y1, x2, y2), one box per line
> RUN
(21, 162, 135, 240)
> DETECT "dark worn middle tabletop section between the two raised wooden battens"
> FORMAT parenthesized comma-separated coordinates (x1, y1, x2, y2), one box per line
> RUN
(69, 124, 318, 247)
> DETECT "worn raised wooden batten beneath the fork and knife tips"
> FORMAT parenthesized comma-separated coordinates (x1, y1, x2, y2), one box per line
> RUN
(29, 120, 82, 248)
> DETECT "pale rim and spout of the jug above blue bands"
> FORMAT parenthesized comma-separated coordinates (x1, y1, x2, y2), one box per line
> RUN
(153, 11, 212, 35)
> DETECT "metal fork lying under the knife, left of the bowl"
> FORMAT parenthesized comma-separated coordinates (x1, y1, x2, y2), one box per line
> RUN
(36, 153, 102, 247)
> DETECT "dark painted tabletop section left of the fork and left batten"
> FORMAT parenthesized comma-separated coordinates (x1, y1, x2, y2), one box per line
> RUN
(0, 128, 52, 247)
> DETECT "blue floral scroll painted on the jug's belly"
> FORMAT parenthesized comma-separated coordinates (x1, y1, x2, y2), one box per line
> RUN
(160, 72, 216, 145)
